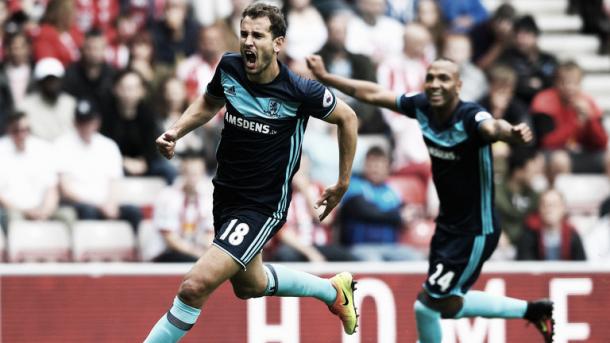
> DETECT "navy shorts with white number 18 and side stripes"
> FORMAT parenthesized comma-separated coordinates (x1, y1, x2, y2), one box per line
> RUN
(212, 210, 285, 269)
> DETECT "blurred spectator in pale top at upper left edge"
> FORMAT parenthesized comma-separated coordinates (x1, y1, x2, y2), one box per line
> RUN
(0, 31, 34, 135)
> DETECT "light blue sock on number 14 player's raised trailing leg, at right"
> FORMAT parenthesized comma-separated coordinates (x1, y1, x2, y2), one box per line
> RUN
(455, 291, 527, 318)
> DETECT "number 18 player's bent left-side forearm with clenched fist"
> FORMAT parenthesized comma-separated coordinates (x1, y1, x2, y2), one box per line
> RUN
(156, 94, 224, 159)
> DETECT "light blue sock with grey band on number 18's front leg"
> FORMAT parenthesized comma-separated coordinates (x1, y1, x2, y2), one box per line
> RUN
(144, 297, 201, 343)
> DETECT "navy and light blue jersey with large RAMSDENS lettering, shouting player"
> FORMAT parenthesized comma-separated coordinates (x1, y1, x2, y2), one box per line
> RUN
(206, 53, 337, 219)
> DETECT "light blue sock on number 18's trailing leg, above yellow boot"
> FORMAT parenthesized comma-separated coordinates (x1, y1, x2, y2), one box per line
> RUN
(265, 264, 337, 306)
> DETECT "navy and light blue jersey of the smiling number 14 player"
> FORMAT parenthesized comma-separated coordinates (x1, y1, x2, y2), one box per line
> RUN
(396, 93, 498, 235)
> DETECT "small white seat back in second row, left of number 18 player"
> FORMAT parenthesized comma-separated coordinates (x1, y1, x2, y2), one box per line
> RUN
(114, 176, 166, 207)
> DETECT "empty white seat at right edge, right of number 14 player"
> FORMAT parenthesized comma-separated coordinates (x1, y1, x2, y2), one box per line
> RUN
(555, 174, 610, 214)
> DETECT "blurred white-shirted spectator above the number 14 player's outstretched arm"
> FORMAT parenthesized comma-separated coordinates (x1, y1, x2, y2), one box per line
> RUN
(345, 0, 404, 64)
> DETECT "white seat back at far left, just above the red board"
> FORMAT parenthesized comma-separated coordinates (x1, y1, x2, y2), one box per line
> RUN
(8, 220, 70, 262)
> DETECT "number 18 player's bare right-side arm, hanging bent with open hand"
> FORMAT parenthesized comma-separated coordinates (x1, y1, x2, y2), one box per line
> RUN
(316, 99, 358, 221)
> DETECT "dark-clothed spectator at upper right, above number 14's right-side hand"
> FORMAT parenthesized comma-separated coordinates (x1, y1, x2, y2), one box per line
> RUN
(500, 15, 557, 105)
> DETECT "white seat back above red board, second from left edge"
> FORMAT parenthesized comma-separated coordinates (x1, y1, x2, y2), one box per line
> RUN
(72, 220, 135, 262)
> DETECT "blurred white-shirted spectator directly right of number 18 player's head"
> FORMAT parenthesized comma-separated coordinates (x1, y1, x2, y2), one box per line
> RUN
(283, 0, 328, 60)
